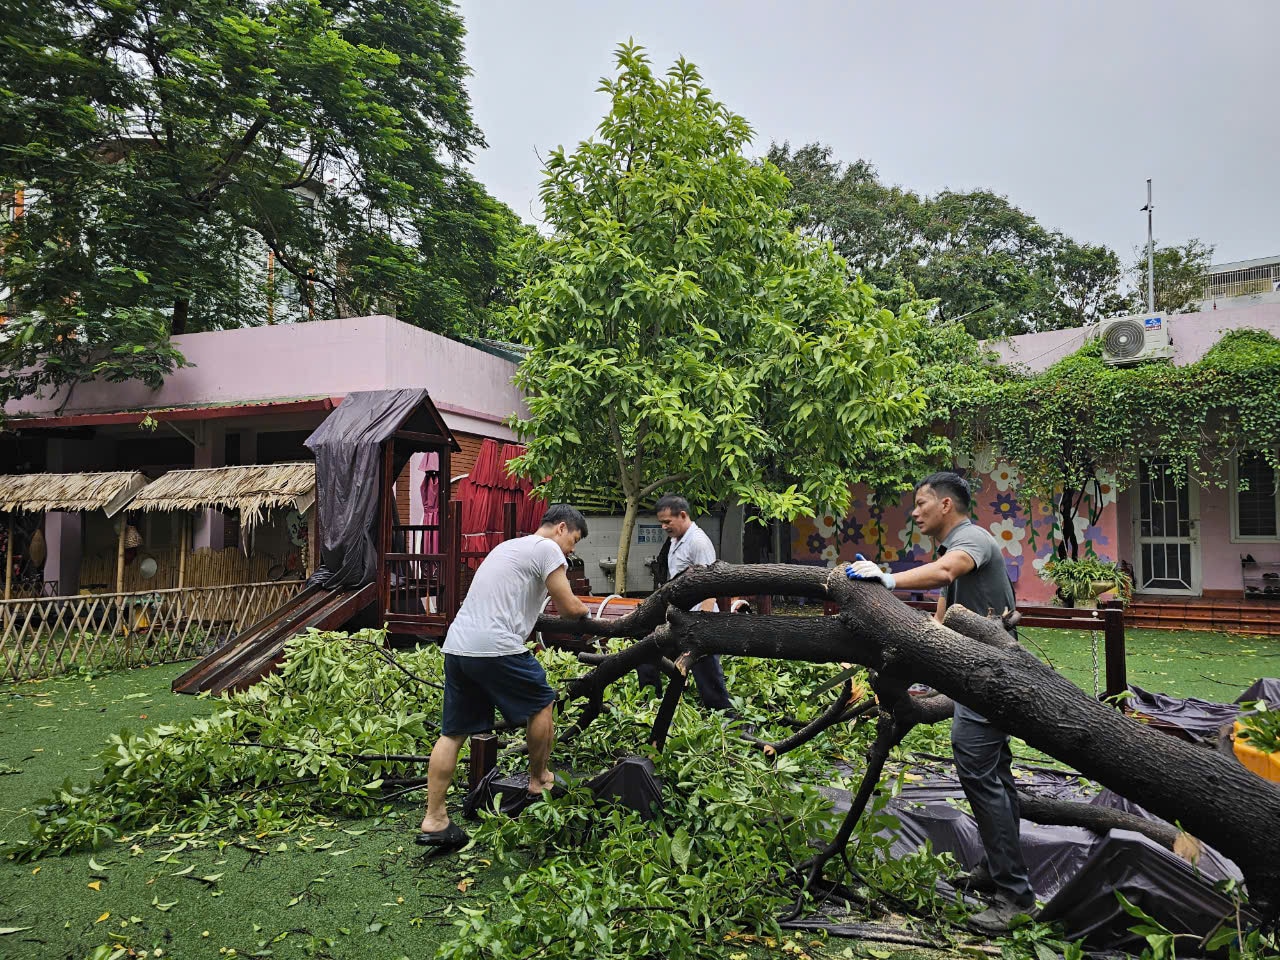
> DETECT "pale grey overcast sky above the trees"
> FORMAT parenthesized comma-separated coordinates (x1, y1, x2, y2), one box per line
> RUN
(461, 0, 1280, 262)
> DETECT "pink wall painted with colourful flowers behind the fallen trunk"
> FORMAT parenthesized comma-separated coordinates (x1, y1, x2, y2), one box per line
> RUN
(791, 454, 1117, 605)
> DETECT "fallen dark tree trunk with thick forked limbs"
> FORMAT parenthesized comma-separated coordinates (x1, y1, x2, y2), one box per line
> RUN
(539, 563, 1280, 919)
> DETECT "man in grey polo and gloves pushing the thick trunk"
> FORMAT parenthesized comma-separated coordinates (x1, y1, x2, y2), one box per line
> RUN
(845, 472, 1036, 933)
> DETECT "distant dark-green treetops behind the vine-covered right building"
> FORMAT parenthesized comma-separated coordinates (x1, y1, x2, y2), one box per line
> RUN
(768, 143, 1125, 338)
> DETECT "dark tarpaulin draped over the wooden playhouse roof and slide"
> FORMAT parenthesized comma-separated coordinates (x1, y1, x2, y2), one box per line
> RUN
(306, 388, 426, 590)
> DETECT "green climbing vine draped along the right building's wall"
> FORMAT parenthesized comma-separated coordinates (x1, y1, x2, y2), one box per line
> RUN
(957, 330, 1280, 557)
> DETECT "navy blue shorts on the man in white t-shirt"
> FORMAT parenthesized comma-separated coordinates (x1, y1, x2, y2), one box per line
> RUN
(440, 650, 556, 736)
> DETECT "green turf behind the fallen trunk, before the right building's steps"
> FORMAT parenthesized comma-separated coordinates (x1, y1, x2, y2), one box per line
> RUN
(1018, 627, 1280, 703)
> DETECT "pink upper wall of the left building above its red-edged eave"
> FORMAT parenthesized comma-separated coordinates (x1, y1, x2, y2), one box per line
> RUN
(5, 316, 527, 439)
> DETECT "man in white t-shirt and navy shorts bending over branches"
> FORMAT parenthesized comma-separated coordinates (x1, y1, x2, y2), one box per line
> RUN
(416, 503, 586, 850)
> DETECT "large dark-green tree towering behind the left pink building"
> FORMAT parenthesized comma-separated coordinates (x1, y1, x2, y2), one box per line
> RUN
(0, 0, 518, 409)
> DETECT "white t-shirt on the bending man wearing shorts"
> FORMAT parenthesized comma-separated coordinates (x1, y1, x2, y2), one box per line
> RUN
(444, 534, 568, 657)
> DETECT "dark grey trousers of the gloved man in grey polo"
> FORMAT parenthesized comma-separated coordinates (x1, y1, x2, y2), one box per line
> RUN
(951, 704, 1036, 908)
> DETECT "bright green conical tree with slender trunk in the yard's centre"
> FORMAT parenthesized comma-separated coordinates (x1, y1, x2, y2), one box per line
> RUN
(515, 45, 923, 591)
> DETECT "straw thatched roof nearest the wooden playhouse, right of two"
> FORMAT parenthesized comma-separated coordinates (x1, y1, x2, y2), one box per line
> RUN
(129, 462, 316, 529)
